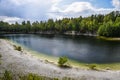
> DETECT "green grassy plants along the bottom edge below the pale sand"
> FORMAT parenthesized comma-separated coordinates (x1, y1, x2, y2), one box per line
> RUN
(0, 70, 74, 80)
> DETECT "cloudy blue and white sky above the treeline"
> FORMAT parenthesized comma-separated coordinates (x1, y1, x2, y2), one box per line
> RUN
(0, 0, 120, 23)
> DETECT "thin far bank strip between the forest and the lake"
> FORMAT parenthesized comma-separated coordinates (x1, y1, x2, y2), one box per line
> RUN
(0, 32, 120, 41)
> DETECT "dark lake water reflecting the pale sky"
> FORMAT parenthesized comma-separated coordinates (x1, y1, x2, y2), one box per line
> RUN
(1, 34, 120, 63)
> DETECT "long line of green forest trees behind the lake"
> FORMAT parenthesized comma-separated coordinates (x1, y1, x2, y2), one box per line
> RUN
(0, 11, 120, 37)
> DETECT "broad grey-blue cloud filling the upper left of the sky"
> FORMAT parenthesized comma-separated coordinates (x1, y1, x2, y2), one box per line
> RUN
(0, 0, 61, 20)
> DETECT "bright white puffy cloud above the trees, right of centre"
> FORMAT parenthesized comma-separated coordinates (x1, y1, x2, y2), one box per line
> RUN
(48, 2, 115, 19)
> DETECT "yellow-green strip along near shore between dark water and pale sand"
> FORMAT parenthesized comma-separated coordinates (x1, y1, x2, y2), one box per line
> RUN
(7, 41, 120, 70)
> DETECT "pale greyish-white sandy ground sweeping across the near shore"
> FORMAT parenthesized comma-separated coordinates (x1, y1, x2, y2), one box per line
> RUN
(0, 39, 120, 80)
